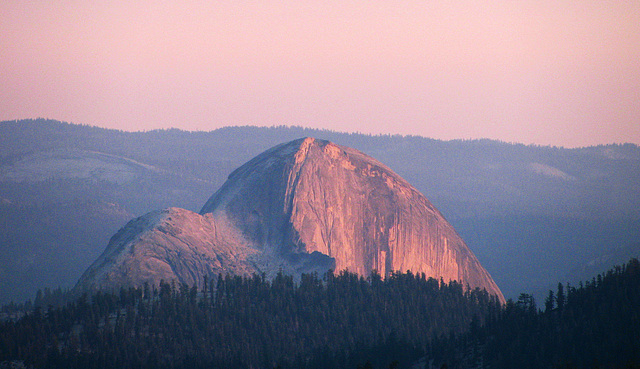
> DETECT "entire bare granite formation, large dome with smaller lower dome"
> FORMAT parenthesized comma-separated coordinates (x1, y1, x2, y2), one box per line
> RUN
(76, 138, 504, 301)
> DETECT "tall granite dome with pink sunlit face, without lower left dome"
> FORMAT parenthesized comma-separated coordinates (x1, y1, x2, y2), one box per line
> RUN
(201, 138, 504, 301)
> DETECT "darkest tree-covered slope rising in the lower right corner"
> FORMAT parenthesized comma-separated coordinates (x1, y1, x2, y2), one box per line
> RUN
(428, 259, 640, 369)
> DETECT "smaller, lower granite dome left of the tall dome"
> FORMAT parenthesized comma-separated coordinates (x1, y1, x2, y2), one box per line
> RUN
(76, 208, 258, 290)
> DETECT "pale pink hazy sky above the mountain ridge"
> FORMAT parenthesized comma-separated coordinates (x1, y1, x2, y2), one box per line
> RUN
(0, 0, 640, 147)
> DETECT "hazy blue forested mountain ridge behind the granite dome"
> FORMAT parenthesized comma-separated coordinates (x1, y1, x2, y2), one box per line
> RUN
(0, 119, 640, 303)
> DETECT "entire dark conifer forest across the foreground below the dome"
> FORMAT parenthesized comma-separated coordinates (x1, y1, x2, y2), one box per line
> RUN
(0, 259, 640, 369)
